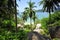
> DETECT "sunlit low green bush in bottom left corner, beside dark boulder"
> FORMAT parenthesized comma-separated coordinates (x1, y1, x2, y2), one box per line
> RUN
(0, 30, 28, 40)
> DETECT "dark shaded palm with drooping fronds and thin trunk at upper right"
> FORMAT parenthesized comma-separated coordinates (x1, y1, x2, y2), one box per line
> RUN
(40, 0, 60, 38)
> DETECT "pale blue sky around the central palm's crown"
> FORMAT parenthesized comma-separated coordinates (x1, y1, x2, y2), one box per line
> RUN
(17, 0, 42, 12)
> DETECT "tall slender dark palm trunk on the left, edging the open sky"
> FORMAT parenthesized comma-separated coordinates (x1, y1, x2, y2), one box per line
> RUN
(8, 0, 20, 32)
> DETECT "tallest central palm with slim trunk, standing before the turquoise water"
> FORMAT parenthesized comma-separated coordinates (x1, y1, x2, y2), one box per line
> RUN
(28, 0, 36, 30)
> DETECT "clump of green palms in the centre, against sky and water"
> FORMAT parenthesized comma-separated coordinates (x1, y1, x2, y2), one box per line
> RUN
(23, 0, 36, 30)
